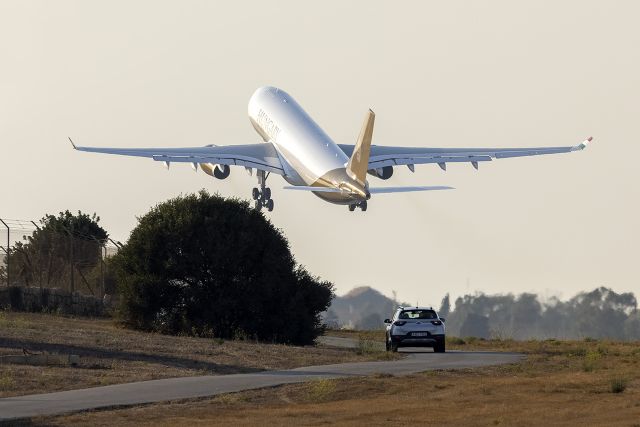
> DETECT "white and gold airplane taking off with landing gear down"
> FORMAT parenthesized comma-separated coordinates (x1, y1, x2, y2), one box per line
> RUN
(69, 86, 592, 211)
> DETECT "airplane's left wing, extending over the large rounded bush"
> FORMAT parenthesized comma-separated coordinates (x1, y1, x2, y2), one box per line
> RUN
(69, 138, 284, 175)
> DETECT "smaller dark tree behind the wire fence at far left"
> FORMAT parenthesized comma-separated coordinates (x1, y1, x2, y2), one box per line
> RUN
(5, 210, 108, 291)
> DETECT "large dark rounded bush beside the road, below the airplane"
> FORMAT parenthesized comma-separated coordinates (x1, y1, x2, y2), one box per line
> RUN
(112, 191, 333, 344)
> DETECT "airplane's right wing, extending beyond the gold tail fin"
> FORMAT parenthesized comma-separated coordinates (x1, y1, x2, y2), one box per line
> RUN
(340, 137, 592, 170)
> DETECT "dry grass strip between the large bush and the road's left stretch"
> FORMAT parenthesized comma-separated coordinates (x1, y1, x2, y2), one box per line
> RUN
(0, 311, 374, 397)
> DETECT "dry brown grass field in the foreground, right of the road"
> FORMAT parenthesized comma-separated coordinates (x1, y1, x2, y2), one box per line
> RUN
(33, 340, 640, 426)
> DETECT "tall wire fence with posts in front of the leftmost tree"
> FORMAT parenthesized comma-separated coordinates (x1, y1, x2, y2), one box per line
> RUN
(0, 218, 121, 297)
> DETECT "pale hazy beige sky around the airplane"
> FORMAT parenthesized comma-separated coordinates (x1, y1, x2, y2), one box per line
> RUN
(0, 0, 640, 305)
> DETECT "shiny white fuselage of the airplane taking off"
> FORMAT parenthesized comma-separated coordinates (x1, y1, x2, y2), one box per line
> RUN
(248, 86, 362, 204)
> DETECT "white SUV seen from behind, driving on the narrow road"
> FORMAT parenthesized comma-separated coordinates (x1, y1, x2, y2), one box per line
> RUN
(384, 307, 445, 353)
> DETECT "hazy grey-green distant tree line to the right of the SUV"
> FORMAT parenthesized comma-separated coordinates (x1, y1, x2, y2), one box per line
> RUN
(439, 287, 640, 340)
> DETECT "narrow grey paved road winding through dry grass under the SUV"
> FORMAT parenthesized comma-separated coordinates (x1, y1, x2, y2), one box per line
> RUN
(0, 341, 524, 420)
